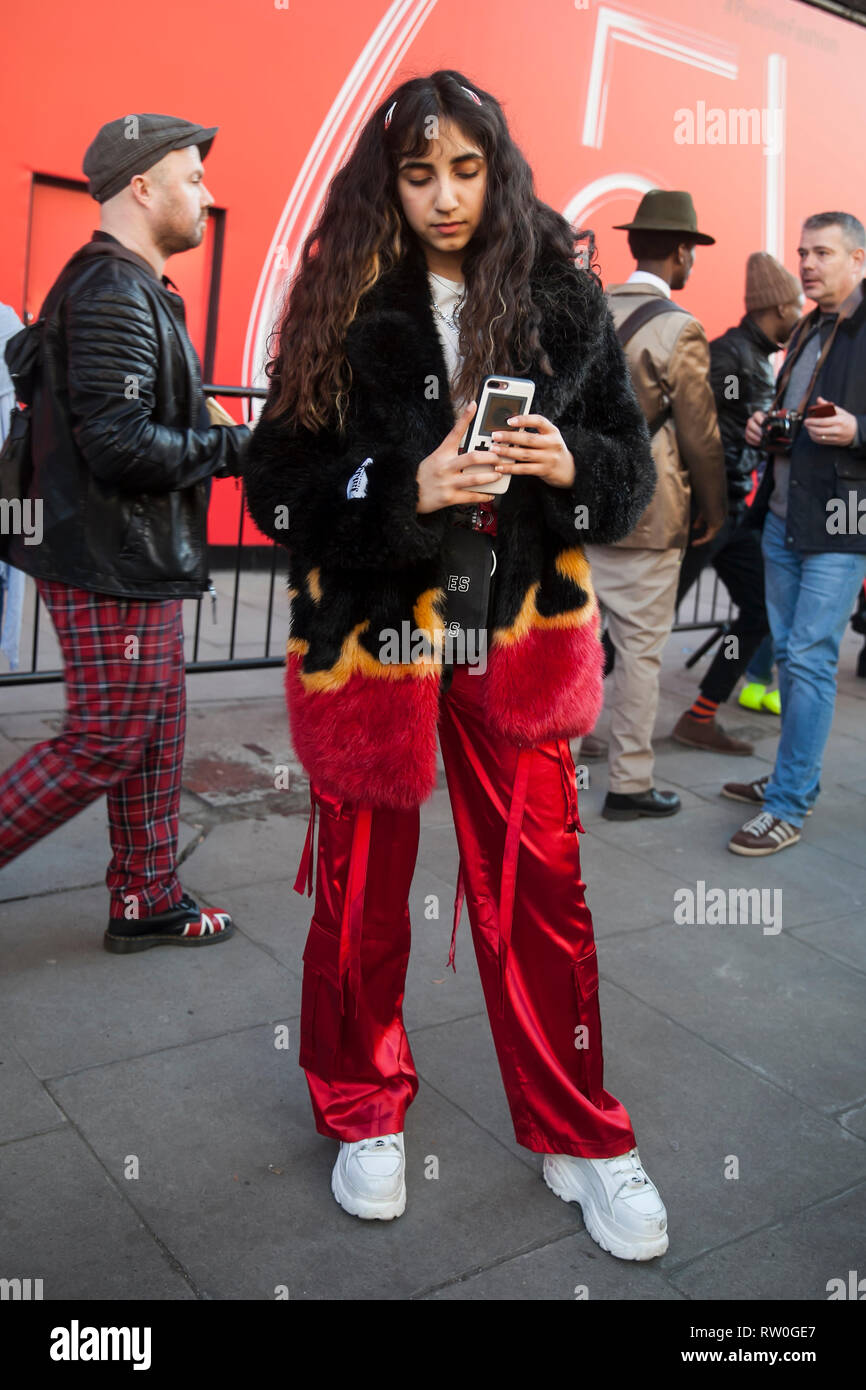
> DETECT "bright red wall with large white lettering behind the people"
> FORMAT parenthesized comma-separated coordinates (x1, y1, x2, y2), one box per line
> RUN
(0, 0, 866, 541)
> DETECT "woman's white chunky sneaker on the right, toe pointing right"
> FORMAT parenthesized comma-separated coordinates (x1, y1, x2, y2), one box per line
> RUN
(544, 1148, 667, 1259)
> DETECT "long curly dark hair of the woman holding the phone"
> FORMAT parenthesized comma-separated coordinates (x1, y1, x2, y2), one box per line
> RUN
(265, 70, 596, 431)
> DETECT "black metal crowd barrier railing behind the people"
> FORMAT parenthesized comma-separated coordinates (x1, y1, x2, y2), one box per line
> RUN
(0, 384, 734, 689)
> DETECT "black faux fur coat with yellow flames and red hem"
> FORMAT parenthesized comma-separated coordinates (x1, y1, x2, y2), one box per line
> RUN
(245, 233, 655, 809)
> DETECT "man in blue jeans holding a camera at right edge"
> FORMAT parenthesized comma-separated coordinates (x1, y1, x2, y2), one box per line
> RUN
(723, 213, 866, 855)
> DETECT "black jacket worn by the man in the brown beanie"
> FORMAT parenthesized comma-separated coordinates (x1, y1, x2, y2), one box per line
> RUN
(710, 314, 778, 521)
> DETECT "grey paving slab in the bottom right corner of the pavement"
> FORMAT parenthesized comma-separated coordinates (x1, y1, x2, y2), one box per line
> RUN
(670, 1184, 866, 1301)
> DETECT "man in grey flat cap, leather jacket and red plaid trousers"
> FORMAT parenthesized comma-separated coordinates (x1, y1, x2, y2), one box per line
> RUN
(0, 114, 250, 952)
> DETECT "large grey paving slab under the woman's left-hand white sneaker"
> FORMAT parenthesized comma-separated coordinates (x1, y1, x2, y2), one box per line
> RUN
(53, 1029, 583, 1300)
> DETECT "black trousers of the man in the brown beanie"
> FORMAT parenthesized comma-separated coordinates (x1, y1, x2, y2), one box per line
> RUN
(677, 520, 770, 705)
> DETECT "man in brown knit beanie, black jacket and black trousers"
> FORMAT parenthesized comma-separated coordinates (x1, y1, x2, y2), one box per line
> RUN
(673, 252, 803, 755)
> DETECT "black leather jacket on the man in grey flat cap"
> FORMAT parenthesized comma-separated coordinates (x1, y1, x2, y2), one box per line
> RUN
(7, 232, 250, 599)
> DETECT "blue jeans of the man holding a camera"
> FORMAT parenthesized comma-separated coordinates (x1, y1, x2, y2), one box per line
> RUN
(762, 512, 866, 827)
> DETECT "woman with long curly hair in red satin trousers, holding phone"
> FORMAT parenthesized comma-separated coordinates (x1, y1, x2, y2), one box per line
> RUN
(246, 71, 667, 1259)
